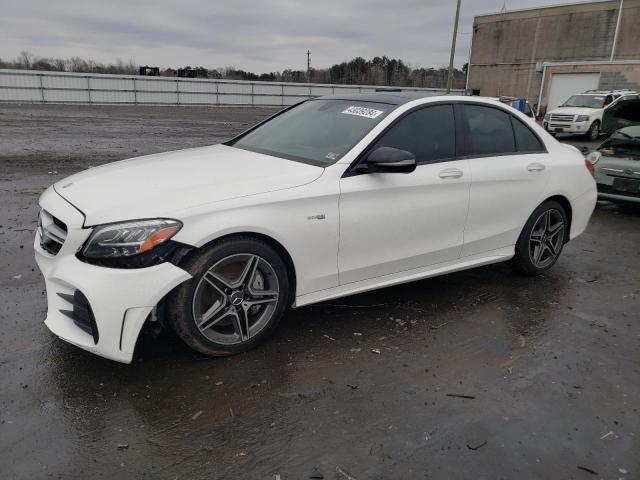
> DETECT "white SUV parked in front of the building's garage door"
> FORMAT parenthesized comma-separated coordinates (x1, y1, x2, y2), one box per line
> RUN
(543, 90, 636, 140)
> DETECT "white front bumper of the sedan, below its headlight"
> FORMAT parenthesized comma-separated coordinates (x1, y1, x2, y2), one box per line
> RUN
(34, 188, 191, 363)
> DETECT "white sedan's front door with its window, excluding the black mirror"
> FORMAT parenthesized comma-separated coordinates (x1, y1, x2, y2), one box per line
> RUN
(338, 104, 470, 284)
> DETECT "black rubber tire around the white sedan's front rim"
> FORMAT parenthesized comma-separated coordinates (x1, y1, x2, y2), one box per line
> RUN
(166, 236, 290, 356)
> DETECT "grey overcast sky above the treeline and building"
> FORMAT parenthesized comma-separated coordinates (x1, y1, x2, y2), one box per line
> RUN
(0, 0, 576, 73)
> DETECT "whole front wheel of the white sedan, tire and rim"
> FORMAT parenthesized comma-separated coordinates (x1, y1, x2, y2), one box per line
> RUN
(167, 237, 289, 356)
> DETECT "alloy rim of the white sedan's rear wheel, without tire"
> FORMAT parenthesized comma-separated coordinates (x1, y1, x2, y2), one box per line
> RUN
(529, 208, 564, 268)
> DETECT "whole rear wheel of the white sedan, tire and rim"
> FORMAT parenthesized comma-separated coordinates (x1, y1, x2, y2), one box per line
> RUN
(512, 201, 568, 276)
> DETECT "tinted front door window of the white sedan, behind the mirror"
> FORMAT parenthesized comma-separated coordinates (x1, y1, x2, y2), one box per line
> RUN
(373, 105, 456, 163)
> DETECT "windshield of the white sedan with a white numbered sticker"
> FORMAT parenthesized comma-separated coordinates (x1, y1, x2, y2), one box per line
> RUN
(228, 100, 395, 167)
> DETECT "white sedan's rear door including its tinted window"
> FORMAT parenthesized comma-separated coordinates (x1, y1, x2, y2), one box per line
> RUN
(462, 104, 549, 257)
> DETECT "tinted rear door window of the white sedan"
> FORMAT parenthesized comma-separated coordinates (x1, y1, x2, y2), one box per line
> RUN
(464, 105, 516, 155)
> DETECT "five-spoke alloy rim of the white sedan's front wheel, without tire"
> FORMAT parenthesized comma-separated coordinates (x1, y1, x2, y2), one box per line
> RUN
(192, 253, 280, 345)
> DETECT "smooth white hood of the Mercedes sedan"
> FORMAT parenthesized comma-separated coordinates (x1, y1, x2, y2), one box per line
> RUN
(54, 145, 324, 226)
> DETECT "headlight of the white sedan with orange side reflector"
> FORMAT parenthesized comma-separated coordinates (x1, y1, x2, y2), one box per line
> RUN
(82, 219, 182, 258)
